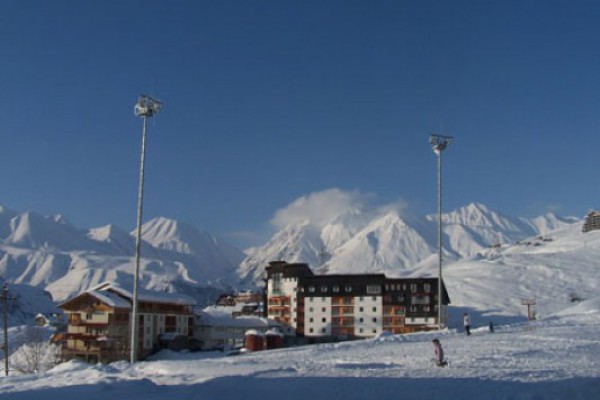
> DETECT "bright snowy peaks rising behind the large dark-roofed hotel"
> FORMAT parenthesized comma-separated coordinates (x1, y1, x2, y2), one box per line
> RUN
(238, 203, 579, 284)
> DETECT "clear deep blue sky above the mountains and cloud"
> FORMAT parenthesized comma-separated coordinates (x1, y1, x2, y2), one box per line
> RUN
(0, 0, 600, 245)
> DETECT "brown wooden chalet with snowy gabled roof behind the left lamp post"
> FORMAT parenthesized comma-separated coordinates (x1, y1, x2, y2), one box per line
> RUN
(59, 283, 195, 363)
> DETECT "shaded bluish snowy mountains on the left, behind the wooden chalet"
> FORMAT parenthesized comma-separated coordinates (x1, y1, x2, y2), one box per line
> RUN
(0, 208, 244, 301)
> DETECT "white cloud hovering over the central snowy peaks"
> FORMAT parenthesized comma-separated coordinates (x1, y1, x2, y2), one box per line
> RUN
(271, 188, 374, 228)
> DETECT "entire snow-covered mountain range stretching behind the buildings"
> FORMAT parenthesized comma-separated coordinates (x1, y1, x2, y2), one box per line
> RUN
(0, 203, 581, 310)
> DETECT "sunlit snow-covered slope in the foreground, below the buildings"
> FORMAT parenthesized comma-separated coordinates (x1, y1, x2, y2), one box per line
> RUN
(0, 298, 600, 400)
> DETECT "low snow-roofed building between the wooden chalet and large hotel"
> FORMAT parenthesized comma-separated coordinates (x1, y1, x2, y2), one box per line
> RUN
(194, 307, 281, 350)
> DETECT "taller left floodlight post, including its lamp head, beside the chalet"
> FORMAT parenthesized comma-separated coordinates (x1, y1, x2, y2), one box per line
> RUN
(130, 94, 162, 364)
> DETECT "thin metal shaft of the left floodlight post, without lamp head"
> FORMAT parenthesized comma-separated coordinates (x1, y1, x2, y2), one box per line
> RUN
(130, 116, 148, 364)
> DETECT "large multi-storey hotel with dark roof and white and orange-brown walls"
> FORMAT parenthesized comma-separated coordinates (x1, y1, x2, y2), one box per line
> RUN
(266, 262, 450, 341)
